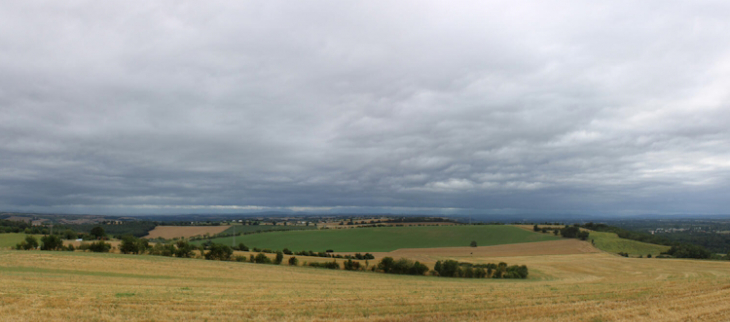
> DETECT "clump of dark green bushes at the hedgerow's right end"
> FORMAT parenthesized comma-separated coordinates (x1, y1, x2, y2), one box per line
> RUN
(433, 260, 529, 278)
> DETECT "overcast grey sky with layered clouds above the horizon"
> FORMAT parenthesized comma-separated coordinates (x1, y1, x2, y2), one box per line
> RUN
(0, 0, 730, 216)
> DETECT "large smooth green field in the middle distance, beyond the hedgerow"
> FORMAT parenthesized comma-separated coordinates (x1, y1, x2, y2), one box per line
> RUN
(195, 225, 560, 252)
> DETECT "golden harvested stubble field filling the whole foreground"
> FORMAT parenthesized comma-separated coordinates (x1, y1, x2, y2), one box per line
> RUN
(0, 251, 730, 321)
